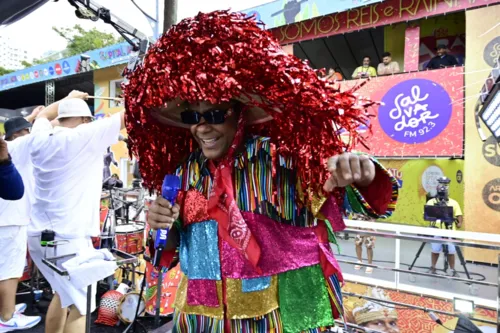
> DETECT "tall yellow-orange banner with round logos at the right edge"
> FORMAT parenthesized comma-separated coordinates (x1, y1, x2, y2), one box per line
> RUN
(465, 8, 500, 263)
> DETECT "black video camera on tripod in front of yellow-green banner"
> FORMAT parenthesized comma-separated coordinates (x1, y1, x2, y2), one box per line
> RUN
(424, 177, 455, 229)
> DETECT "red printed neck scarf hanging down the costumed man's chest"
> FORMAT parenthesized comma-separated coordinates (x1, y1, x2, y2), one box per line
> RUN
(208, 111, 260, 270)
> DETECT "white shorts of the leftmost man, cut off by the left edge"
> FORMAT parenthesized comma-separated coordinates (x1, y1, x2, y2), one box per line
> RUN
(0, 225, 28, 281)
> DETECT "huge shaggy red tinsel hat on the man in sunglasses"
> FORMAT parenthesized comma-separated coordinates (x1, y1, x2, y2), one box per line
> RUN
(124, 11, 373, 193)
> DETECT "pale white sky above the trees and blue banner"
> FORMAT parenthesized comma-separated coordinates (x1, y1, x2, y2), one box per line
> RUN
(0, 0, 273, 58)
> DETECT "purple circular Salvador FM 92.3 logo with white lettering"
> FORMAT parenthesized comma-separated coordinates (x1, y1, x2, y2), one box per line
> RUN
(378, 79, 452, 143)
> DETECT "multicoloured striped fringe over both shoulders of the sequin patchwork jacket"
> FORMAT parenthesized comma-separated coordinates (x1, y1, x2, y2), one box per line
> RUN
(176, 137, 314, 227)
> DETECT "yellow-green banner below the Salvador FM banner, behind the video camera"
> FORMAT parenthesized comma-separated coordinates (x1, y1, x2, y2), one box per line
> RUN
(380, 159, 468, 227)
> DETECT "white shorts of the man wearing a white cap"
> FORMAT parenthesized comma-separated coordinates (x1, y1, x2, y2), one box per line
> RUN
(28, 236, 96, 315)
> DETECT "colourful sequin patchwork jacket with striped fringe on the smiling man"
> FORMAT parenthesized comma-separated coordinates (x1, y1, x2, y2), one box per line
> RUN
(154, 137, 398, 333)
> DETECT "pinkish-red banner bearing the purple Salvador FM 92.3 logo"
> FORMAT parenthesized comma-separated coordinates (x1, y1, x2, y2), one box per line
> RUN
(341, 67, 464, 157)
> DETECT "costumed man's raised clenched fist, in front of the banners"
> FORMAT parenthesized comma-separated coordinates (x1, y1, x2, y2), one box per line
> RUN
(323, 153, 375, 192)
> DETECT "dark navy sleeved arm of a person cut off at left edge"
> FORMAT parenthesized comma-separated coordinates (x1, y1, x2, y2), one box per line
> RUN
(0, 137, 24, 200)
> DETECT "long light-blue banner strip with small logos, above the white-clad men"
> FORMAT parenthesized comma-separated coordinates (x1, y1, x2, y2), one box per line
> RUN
(0, 43, 132, 91)
